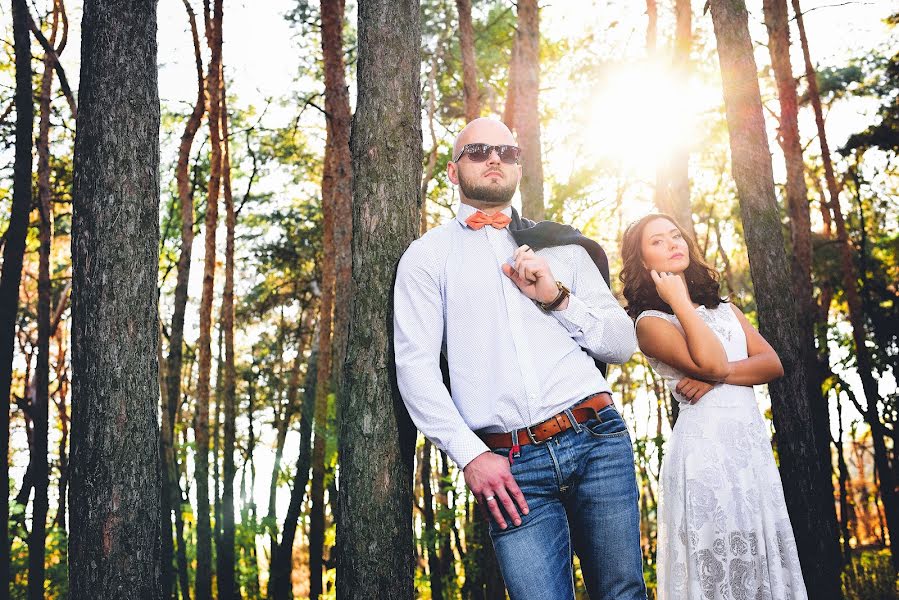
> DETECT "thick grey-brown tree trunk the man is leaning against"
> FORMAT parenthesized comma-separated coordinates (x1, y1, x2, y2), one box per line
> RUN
(337, 0, 422, 600)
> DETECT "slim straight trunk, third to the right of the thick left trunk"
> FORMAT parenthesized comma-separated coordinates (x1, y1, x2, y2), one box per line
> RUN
(218, 64, 240, 600)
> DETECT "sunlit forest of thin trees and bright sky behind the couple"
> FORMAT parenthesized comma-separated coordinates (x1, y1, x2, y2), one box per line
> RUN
(0, 0, 899, 598)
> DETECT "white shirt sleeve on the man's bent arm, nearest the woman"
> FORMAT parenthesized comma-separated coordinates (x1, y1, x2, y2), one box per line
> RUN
(552, 246, 637, 364)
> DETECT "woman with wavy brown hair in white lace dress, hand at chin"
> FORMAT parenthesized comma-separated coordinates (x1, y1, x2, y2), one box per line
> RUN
(621, 214, 807, 600)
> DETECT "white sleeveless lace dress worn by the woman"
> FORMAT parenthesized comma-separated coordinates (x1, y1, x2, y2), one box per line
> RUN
(637, 303, 808, 600)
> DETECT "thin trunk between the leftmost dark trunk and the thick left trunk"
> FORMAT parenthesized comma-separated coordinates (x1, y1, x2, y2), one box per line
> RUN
(28, 2, 59, 600)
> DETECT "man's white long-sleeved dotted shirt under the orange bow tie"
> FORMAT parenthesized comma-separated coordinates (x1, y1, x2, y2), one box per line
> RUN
(393, 204, 637, 468)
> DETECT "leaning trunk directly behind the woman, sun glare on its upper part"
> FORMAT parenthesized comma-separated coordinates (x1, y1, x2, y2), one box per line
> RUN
(710, 0, 840, 599)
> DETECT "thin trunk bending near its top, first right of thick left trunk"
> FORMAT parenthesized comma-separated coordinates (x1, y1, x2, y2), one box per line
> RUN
(162, 0, 206, 598)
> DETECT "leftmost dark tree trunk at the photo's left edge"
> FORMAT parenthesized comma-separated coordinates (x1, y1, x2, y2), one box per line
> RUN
(0, 0, 34, 590)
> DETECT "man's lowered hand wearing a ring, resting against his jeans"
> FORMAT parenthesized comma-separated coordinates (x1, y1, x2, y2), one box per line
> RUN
(463, 452, 529, 529)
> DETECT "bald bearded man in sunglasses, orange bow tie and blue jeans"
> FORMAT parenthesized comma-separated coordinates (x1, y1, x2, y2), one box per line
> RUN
(394, 118, 646, 600)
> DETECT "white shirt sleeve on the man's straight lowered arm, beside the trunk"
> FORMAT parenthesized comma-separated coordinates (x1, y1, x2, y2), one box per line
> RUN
(393, 240, 488, 468)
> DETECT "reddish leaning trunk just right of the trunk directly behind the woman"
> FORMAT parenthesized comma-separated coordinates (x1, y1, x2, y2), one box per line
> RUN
(762, 0, 833, 524)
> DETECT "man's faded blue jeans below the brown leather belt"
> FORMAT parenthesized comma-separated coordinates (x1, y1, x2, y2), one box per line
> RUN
(490, 405, 646, 600)
